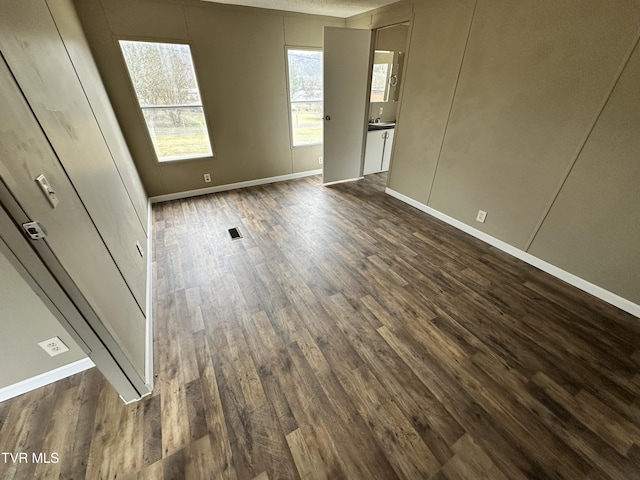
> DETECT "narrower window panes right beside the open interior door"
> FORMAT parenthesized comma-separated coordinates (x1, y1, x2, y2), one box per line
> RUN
(287, 49, 322, 147)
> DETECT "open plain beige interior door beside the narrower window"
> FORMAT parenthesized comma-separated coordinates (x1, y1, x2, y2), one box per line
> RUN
(322, 27, 371, 183)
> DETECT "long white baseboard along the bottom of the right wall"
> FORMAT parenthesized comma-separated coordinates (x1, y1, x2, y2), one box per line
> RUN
(385, 187, 640, 318)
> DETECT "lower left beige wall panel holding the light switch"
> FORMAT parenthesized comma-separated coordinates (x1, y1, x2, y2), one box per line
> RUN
(0, 55, 148, 400)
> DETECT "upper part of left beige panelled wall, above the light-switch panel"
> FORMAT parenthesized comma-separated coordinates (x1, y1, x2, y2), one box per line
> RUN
(0, 0, 147, 313)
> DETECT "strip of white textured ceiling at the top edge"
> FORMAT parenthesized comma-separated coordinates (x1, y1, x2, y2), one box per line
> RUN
(204, 0, 398, 18)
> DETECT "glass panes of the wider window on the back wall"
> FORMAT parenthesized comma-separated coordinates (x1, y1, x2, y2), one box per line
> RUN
(120, 40, 213, 162)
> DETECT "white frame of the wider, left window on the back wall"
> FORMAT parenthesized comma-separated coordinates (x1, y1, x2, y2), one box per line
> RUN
(113, 36, 216, 166)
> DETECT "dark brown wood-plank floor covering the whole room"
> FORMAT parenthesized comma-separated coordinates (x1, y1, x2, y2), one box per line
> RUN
(0, 175, 640, 480)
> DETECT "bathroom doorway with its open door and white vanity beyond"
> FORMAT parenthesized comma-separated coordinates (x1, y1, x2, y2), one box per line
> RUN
(323, 20, 410, 187)
